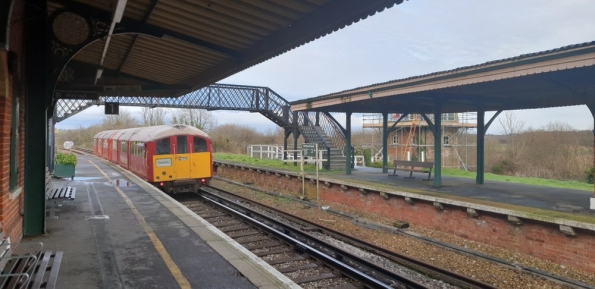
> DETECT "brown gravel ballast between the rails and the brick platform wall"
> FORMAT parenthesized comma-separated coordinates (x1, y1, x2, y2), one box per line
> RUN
(211, 180, 595, 288)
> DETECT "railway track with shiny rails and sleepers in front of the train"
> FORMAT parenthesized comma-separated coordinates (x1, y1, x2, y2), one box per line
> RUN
(174, 187, 493, 288)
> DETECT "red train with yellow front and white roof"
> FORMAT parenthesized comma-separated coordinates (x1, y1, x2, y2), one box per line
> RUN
(93, 124, 213, 194)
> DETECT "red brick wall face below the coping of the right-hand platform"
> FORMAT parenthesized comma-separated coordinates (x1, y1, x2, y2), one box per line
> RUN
(216, 166, 595, 273)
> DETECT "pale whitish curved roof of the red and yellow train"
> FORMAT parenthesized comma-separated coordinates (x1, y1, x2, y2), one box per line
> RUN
(94, 124, 210, 142)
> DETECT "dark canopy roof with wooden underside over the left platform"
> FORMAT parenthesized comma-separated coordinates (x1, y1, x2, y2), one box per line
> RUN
(47, 0, 403, 99)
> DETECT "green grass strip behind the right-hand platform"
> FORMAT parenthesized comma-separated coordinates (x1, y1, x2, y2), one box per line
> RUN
(213, 153, 593, 192)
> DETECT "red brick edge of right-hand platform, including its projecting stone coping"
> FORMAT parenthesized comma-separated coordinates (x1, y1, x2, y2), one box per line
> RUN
(214, 161, 595, 273)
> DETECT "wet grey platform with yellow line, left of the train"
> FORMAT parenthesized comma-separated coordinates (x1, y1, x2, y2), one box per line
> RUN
(23, 155, 299, 289)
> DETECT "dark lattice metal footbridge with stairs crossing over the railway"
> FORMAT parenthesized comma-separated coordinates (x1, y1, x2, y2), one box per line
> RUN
(54, 84, 346, 169)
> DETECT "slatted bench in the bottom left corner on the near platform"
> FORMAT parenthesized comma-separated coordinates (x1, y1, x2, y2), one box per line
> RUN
(0, 223, 63, 289)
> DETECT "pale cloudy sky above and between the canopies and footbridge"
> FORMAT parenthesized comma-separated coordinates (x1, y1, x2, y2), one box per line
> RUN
(56, 0, 595, 134)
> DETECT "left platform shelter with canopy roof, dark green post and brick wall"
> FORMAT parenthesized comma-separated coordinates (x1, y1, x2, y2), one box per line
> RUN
(0, 0, 402, 237)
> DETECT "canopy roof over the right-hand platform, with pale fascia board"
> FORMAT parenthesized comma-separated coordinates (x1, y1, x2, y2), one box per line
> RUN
(291, 41, 595, 113)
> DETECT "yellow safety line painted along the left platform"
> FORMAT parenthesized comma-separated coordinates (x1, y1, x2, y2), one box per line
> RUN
(89, 160, 192, 289)
